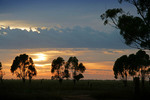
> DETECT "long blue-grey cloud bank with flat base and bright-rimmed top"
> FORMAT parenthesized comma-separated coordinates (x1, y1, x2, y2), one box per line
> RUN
(0, 26, 126, 49)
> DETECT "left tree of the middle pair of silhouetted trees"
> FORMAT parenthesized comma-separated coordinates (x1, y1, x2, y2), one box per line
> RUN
(51, 57, 65, 83)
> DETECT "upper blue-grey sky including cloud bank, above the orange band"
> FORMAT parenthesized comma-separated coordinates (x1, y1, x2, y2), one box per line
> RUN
(0, 0, 134, 49)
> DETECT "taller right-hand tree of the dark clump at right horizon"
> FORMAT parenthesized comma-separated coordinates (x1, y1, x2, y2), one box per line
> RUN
(128, 50, 150, 86)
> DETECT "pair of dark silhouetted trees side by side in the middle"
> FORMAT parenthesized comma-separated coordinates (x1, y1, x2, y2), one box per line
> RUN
(51, 57, 86, 83)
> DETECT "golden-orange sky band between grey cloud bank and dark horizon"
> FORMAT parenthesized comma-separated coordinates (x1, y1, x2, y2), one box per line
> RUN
(0, 48, 142, 79)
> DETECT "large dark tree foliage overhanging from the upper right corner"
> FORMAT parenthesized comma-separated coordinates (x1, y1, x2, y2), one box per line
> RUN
(101, 0, 150, 50)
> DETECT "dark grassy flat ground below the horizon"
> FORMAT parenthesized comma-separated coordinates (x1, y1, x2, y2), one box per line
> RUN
(0, 80, 150, 100)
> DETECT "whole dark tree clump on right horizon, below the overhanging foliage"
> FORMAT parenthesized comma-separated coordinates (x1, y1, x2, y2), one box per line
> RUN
(113, 50, 150, 94)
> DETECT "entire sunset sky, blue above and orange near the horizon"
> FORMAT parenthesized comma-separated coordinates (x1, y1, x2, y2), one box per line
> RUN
(0, 0, 144, 79)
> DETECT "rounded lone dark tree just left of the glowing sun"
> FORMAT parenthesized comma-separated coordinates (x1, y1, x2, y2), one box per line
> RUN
(10, 54, 37, 82)
